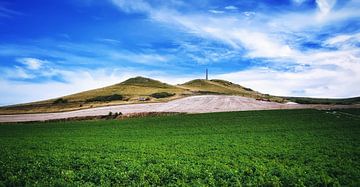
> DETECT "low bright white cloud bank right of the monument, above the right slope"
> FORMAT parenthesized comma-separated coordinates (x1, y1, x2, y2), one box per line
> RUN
(213, 68, 360, 98)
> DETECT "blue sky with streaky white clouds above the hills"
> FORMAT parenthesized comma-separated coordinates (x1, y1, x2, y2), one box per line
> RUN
(0, 0, 360, 105)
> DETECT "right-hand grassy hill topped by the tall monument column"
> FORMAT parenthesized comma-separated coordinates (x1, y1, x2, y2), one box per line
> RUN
(179, 79, 285, 102)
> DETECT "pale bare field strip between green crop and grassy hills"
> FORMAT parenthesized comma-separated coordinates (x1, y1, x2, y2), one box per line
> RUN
(0, 95, 360, 122)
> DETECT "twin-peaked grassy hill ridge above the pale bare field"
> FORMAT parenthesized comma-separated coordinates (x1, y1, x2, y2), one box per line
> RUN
(0, 77, 360, 114)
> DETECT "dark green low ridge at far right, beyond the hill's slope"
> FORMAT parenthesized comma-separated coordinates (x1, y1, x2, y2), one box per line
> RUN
(286, 97, 360, 105)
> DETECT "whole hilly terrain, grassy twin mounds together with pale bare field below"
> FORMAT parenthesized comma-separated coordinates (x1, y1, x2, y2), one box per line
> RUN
(0, 77, 360, 118)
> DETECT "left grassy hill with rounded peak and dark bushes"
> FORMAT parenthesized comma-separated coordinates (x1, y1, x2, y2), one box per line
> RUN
(0, 77, 191, 114)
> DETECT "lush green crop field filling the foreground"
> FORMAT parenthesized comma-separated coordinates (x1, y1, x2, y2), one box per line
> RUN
(0, 109, 360, 186)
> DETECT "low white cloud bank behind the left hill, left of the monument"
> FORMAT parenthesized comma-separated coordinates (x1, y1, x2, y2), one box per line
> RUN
(0, 68, 199, 105)
